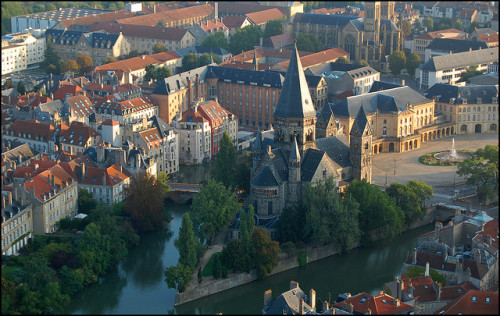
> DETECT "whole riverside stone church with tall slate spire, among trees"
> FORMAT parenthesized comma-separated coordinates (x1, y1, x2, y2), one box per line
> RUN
(247, 47, 372, 219)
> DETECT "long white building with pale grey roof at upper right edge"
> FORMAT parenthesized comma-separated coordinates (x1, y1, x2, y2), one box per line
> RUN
(415, 48, 498, 89)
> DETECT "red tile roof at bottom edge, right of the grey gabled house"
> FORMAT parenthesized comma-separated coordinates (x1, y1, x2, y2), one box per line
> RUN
(335, 291, 413, 315)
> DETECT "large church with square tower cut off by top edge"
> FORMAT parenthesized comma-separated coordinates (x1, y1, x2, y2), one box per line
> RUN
(287, 1, 404, 70)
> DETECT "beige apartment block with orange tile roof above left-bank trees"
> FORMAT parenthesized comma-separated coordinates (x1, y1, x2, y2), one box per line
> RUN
(19, 165, 78, 234)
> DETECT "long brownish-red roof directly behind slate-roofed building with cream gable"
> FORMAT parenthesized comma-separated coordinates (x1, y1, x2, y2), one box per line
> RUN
(90, 22, 188, 41)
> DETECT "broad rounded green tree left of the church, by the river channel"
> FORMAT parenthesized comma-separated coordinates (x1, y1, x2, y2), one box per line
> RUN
(191, 179, 238, 244)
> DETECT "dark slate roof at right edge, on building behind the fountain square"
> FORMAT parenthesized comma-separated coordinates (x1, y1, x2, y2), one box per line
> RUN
(426, 83, 498, 104)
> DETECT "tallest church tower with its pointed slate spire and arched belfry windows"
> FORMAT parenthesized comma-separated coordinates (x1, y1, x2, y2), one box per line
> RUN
(273, 46, 316, 154)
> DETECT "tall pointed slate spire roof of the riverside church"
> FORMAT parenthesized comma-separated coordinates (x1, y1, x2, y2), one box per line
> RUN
(274, 46, 316, 118)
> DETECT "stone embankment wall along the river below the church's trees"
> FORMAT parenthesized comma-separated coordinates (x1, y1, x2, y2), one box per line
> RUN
(175, 207, 441, 306)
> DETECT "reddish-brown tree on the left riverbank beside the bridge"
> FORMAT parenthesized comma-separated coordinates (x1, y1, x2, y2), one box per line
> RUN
(125, 171, 165, 231)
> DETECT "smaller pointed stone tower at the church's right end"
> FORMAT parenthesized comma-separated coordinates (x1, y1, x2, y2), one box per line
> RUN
(349, 106, 373, 183)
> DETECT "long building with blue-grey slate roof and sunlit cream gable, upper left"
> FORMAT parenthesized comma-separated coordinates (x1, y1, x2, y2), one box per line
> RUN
(45, 29, 130, 65)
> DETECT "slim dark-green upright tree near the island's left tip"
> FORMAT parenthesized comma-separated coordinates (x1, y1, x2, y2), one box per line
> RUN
(174, 213, 199, 269)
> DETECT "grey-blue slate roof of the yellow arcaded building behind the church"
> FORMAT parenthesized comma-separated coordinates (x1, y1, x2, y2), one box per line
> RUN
(332, 86, 430, 117)
